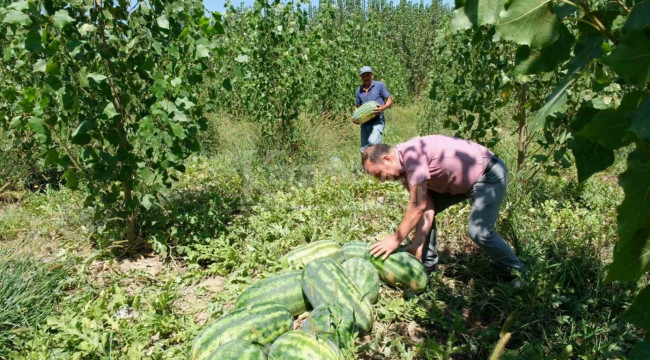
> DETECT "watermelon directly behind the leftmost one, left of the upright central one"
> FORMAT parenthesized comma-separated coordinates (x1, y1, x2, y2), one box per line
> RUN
(235, 271, 309, 316)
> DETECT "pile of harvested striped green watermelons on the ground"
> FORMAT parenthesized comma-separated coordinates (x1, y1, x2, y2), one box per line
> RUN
(191, 240, 428, 360)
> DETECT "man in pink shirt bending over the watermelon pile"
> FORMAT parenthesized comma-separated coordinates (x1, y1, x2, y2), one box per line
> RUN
(362, 135, 523, 281)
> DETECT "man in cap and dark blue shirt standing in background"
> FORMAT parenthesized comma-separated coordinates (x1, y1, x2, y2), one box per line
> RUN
(353, 66, 393, 154)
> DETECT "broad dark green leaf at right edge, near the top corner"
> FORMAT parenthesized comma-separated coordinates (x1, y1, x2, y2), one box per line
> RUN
(600, 31, 650, 88)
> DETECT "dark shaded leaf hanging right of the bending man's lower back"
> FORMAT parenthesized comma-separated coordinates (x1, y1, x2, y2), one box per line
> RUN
(571, 137, 614, 182)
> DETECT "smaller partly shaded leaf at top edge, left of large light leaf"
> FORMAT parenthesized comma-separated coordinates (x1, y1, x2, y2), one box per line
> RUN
(451, 0, 504, 31)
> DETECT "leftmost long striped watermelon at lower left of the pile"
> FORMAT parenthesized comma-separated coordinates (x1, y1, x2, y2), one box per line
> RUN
(191, 303, 293, 360)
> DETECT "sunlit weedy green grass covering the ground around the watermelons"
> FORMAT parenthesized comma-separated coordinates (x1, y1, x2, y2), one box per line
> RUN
(0, 102, 643, 359)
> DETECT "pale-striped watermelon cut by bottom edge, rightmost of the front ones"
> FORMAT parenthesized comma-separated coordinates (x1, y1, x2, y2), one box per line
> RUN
(269, 330, 343, 360)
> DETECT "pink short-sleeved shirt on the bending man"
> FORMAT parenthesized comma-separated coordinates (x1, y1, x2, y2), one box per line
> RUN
(395, 135, 494, 194)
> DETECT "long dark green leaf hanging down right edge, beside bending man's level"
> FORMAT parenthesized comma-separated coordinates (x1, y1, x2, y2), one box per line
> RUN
(607, 153, 650, 281)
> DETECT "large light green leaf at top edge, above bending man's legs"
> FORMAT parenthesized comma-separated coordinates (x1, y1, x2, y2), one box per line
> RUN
(497, 0, 563, 48)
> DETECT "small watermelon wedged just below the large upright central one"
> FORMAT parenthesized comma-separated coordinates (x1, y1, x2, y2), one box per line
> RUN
(302, 303, 357, 348)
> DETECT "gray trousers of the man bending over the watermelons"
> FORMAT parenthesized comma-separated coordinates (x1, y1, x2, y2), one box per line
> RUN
(422, 159, 523, 269)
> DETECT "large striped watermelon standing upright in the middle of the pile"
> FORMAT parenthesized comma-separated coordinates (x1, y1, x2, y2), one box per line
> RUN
(302, 258, 373, 333)
